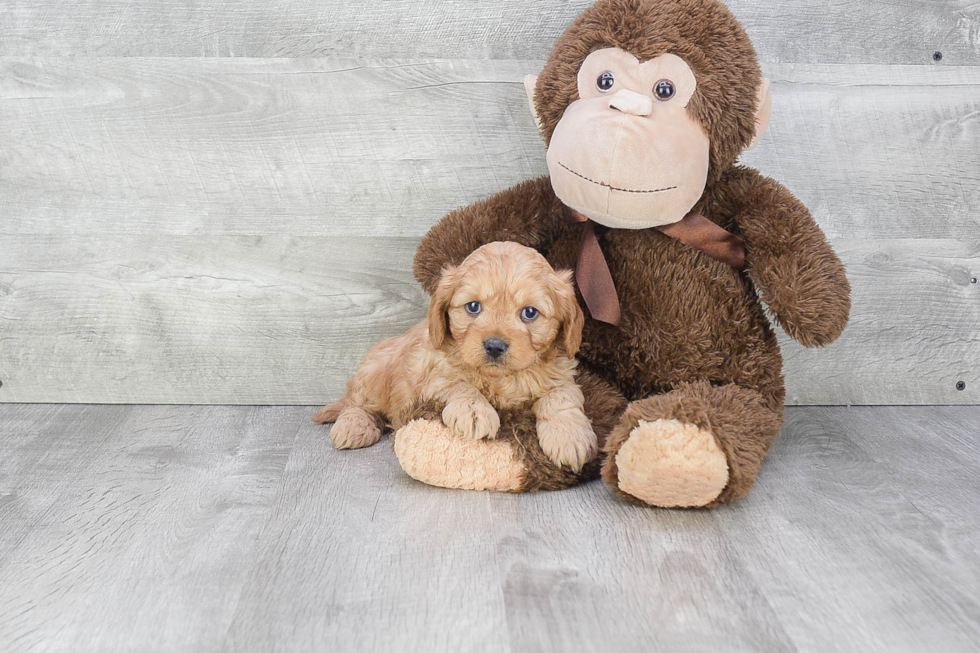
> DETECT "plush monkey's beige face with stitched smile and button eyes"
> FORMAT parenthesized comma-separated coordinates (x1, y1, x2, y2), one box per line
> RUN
(547, 48, 710, 229)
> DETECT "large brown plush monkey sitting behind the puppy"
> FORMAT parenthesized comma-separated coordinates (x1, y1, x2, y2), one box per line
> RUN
(395, 0, 850, 507)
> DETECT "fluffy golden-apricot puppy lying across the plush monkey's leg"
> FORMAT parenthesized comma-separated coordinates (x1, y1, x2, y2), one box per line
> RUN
(313, 242, 597, 471)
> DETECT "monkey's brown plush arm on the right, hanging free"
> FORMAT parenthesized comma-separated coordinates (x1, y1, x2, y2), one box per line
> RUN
(732, 168, 851, 347)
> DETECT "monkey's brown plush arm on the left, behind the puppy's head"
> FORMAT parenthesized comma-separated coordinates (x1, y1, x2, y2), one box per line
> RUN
(414, 177, 560, 294)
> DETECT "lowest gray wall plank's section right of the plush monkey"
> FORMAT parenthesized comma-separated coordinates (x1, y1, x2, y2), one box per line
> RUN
(776, 237, 980, 405)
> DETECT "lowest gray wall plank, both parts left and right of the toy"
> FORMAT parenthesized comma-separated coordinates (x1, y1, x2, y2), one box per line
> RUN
(0, 236, 980, 404)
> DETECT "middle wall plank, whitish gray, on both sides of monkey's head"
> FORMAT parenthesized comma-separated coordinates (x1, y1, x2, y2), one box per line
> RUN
(0, 58, 980, 238)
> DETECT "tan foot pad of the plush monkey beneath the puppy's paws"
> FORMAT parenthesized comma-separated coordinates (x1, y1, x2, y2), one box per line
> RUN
(395, 419, 525, 492)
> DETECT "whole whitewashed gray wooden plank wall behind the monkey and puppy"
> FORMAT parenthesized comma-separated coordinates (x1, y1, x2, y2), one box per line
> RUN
(0, 0, 980, 404)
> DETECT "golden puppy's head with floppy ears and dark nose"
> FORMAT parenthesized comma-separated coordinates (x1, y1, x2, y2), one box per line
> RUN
(429, 242, 585, 376)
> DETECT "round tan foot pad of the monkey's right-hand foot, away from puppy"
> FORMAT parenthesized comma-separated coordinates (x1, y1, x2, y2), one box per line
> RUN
(616, 419, 728, 508)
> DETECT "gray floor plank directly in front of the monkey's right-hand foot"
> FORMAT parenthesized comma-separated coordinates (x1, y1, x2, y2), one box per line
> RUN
(492, 482, 793, 653)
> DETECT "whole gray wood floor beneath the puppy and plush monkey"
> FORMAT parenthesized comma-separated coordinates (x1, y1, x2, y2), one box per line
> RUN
(0, 405, 980, 652)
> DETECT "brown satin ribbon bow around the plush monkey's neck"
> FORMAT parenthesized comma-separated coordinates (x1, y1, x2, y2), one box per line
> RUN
(562, 204, 745, 325)
